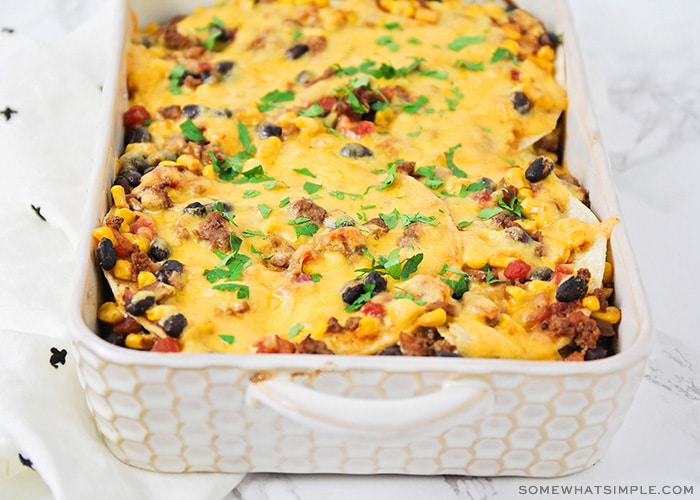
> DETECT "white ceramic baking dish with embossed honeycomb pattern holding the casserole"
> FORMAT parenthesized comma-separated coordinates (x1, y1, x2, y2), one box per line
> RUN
(72, 0, 652, 477)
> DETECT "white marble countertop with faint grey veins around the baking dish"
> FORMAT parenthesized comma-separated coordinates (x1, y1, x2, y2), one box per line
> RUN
(0, 0, 700, 500)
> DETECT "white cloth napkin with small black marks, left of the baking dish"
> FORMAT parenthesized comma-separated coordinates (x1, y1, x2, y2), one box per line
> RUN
(0, 0, 243, 500)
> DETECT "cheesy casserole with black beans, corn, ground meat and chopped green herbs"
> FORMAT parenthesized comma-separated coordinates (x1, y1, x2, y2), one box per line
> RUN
(95, 0, 619, 359)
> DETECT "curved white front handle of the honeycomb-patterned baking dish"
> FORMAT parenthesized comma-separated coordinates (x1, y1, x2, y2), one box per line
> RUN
(246, 374, 494, 440)
